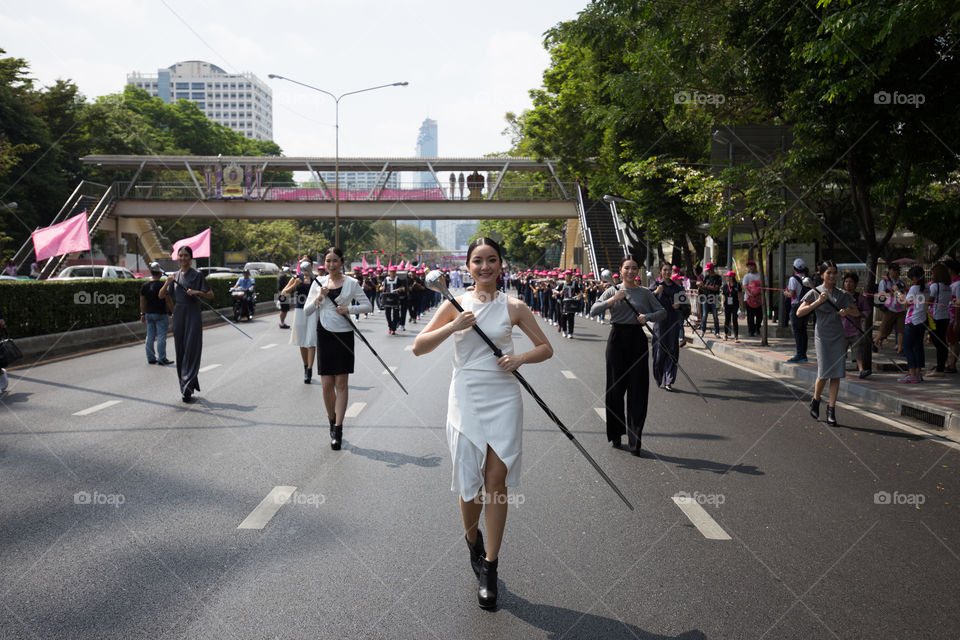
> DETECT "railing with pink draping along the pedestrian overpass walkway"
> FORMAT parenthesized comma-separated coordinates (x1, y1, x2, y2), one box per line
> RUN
(115, 181, 576, 202)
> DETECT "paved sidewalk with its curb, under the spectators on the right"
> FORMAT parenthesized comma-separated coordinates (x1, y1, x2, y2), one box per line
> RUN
(684, 322, 960, 442)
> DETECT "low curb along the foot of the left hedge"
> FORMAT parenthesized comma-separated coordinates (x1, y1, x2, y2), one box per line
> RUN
(10, 300, 276, 370)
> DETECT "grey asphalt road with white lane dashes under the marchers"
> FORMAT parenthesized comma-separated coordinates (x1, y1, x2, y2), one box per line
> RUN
(0, 298, 960, 639)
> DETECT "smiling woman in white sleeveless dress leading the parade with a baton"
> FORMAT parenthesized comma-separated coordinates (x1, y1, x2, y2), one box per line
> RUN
(413, 238, 553, 609)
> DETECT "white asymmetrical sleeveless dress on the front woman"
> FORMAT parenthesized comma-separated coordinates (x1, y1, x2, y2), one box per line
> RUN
(447, 292, 523, 501)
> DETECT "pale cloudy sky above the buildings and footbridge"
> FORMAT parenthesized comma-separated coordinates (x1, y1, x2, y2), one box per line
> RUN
(0, 0, 588, 157)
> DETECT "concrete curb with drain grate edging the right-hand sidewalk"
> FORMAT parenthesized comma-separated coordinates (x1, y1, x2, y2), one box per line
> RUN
(686, 332, 960, 442)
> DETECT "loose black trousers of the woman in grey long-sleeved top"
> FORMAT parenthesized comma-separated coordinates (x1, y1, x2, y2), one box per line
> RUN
(605, 324, 650, 451)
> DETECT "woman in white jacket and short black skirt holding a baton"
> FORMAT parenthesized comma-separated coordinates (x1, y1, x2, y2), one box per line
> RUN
(303, 247, 373, 451)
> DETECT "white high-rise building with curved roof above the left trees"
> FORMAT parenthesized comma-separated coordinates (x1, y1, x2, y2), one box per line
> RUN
(127, 60, 273, 140)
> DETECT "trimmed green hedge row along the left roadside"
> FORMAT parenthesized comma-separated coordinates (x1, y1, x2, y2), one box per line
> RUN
(0, 276, 277, 338)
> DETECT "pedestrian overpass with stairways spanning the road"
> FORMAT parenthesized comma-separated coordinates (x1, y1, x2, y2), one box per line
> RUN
(14, 155, 625, 278)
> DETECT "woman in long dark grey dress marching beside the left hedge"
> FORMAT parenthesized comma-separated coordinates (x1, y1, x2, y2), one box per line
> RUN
(157, 247, 213, 402)
